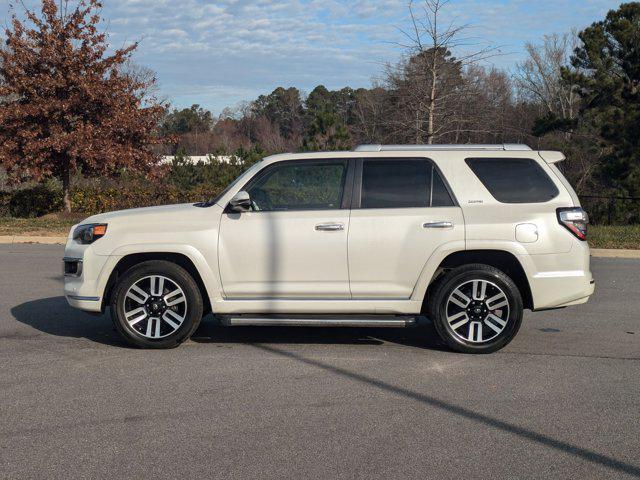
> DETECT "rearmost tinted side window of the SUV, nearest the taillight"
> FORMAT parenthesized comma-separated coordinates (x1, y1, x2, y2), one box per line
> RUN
(465, 158, 560, 203)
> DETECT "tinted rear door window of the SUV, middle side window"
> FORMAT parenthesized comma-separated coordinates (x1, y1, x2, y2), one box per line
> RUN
(360, 159, 454, 208)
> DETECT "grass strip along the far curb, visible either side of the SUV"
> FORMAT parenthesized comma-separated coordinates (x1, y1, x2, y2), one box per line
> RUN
(0, 214, 640, 249)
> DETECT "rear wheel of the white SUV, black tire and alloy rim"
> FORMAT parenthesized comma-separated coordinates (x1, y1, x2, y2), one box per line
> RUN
(427, 264, 523, 353)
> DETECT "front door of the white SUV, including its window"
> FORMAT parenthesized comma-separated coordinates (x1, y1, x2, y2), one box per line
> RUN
(219, 159, 350, 299)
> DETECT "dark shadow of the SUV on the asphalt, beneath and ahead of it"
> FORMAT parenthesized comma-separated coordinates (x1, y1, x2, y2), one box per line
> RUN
(11, 296, 446, 350)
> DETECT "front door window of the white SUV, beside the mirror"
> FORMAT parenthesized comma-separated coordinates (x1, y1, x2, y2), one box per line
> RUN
(247, 160, 347, 211)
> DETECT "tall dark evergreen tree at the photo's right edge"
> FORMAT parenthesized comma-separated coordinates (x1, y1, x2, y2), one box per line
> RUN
(563, 2, 640, 195)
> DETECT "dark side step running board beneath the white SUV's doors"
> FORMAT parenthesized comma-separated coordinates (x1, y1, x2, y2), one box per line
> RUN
(219, 315, 417, 327)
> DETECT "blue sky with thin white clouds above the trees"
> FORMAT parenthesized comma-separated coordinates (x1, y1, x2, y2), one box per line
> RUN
(0, 0, 620, 114)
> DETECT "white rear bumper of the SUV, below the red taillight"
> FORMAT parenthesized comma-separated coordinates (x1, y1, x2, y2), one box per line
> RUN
(521, 240, 595, 310)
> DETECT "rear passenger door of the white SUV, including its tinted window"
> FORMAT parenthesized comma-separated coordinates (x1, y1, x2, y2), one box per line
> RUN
(348, 158, 464, 299)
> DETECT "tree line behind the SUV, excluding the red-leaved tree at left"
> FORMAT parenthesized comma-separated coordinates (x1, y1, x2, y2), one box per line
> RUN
(162, 0, 640, 208)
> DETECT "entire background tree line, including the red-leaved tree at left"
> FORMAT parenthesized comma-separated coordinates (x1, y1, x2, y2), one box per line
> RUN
(0, 0, 640, 220)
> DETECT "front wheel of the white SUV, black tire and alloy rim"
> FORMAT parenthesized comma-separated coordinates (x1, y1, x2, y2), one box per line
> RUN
(111, 260, 202, 348)
